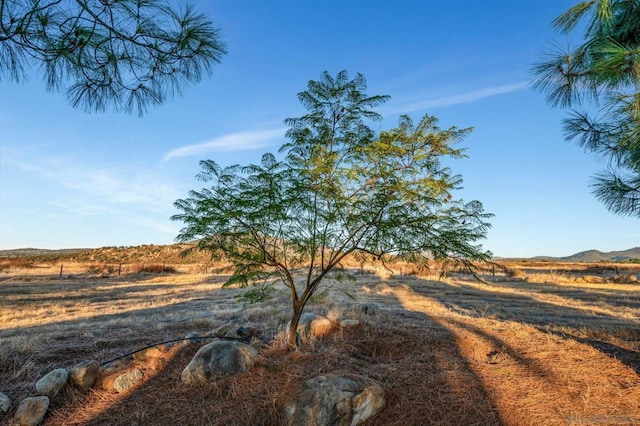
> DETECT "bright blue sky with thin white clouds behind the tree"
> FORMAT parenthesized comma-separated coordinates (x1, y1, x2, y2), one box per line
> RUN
(0, 0, 640, 257)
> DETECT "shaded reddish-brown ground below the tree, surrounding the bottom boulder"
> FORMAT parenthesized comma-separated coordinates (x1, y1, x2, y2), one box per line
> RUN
(46, 312, 503, 426)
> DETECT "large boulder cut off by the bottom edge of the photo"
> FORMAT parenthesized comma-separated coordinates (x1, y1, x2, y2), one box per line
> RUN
(285, 375, 386, 426)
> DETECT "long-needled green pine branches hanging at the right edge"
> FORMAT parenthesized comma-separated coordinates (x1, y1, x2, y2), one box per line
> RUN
(534, 0, 640, 217)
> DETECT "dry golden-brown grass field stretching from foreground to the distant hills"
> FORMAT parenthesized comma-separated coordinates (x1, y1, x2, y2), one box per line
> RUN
(0, 251, 640, 425)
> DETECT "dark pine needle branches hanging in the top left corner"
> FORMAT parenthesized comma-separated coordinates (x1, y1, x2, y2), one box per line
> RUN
(0, 0, 226, 115)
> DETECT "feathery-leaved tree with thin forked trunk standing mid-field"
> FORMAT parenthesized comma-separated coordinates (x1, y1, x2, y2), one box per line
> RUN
(172, 71, 491, 348)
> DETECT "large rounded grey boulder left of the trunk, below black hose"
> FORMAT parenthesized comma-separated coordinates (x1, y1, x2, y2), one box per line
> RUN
(181, 340, 258, 383)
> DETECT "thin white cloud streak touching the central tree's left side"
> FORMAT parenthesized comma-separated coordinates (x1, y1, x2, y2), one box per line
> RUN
(162, 128, 285, 162)
